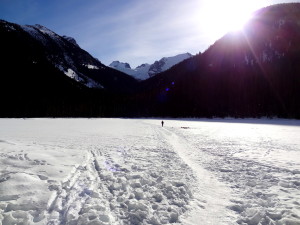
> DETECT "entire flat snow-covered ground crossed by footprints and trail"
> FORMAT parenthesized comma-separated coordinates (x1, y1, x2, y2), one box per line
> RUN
(0, 119, 300, 225)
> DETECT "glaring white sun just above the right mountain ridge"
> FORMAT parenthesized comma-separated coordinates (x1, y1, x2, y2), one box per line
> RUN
(199, 0, 260, 39)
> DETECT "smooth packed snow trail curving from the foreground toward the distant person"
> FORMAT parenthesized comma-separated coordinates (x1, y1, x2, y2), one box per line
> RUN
(156, 125, 235, 224)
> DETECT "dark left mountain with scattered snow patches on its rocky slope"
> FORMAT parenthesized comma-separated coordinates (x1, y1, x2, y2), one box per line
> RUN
(0, 20, 137, 117)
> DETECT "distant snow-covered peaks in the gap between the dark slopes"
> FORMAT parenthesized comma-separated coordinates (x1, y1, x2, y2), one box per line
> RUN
(109, 53, 192, 80)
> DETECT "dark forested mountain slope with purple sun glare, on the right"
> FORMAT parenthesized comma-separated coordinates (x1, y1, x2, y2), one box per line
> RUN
(137, 3, 300, 118)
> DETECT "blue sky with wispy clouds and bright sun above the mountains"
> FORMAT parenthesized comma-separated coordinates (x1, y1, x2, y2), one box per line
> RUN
(0, 0, 300, 67)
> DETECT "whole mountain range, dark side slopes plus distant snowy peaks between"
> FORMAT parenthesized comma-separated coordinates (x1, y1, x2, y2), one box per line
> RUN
(0, 3, 300, 119)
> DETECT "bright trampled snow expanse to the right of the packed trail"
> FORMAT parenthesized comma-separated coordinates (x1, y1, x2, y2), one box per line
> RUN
(152, 120, 300, 225)
